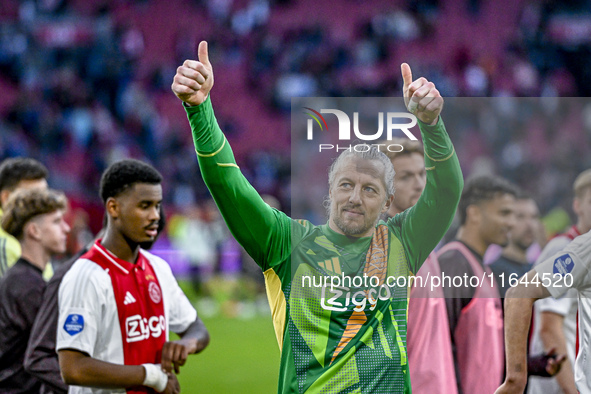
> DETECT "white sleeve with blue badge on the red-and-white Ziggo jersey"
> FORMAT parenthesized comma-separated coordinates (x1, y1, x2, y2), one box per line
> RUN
(56, 260, 110, 355)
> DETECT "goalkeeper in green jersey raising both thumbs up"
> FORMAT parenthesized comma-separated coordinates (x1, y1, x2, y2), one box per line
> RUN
(172, 42, 463, 393)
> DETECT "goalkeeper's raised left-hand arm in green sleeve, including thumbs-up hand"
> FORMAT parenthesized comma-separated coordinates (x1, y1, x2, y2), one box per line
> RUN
(172, 41, 291, 270)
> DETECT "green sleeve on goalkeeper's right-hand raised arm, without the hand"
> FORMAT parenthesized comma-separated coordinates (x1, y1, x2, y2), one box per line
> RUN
(388, 117, 464, 272)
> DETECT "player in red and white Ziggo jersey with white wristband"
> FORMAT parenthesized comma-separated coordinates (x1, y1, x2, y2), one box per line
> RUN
(56, 160, 209, 394)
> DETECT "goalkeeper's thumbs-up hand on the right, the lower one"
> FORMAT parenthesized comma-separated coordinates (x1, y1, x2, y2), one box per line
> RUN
(400, 63, 443, 125)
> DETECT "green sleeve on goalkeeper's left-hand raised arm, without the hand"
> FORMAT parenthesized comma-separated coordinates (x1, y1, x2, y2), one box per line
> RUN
(185, 97, 291, 270)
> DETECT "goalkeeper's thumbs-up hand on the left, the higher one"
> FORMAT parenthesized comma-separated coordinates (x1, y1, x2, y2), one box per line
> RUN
(171, 41, 213, 105)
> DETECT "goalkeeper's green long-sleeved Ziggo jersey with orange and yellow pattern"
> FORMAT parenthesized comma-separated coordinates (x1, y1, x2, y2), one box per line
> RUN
(186, 98, 463, 393)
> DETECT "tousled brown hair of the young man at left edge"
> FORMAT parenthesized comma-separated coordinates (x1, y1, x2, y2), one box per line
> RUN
(2, 189, 68, 239)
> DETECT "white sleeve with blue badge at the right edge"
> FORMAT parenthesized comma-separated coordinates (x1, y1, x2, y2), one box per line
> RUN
(534, 231, 591, 298)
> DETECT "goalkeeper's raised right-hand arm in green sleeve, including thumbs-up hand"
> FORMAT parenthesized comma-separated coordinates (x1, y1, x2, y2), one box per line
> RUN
(393, 63, 464, 273)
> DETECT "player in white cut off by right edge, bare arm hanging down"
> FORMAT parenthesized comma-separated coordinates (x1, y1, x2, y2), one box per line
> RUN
(497, 231, 591, 394)
